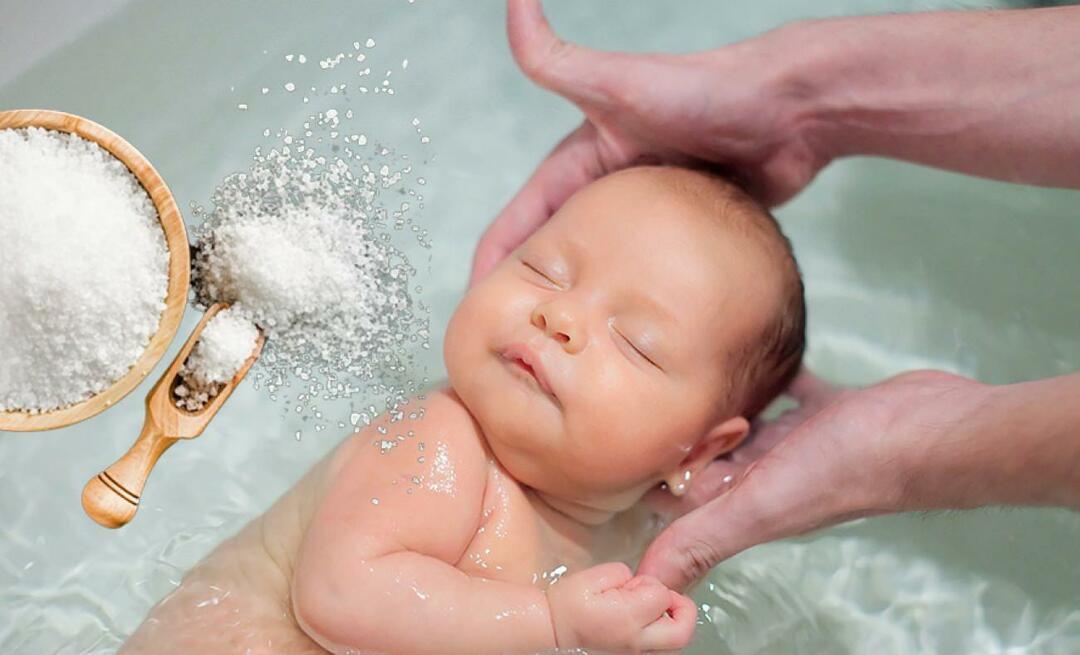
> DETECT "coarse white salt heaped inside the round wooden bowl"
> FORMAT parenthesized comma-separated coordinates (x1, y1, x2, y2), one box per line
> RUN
(0, 128, 168, 413)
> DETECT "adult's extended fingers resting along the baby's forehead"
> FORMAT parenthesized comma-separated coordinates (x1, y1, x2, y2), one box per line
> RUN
(469, 122, 605, 286)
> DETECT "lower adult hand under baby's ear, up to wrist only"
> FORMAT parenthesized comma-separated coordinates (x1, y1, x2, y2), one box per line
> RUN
(638, 371, 1002, 589)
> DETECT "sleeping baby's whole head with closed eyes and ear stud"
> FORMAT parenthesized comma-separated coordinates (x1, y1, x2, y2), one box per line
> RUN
(444, 166, 806, 516)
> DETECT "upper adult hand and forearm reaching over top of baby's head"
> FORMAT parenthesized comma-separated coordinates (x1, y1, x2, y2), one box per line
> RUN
(471, 0, 1080, 283)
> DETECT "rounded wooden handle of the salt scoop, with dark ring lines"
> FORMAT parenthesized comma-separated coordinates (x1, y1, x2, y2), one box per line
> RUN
(82, 416, 177, 527)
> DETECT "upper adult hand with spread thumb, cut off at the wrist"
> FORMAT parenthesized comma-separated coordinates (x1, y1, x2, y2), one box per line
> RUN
(470, 0, 829, 284)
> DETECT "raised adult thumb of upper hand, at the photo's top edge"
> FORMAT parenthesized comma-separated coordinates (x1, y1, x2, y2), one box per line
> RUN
(507, 0, 627, 106)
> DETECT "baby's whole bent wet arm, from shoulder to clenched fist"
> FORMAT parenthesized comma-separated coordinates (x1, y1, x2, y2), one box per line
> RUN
(293, 395, 697, 655)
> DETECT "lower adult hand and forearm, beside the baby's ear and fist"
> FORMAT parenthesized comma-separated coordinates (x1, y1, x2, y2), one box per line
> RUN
(638, 371, 1080, 589)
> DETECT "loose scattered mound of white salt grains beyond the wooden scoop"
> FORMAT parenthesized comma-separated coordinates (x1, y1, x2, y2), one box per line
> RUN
(192, 87, 430, 431)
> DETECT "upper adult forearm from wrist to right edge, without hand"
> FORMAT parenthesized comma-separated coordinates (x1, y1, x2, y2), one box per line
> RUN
(786, 6, 1080, 188)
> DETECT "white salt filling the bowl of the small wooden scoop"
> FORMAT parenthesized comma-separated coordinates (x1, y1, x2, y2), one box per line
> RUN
(173, 307, 259, 412)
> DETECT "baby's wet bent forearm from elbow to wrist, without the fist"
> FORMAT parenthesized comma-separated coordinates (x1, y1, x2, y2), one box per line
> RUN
(294, 552, 555, 655)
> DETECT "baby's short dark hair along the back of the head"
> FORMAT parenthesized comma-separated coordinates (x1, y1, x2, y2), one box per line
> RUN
(639, 166, 807, 418)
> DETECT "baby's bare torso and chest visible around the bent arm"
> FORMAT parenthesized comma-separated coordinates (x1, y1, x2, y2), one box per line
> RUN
(120, 389, 654, 655)
